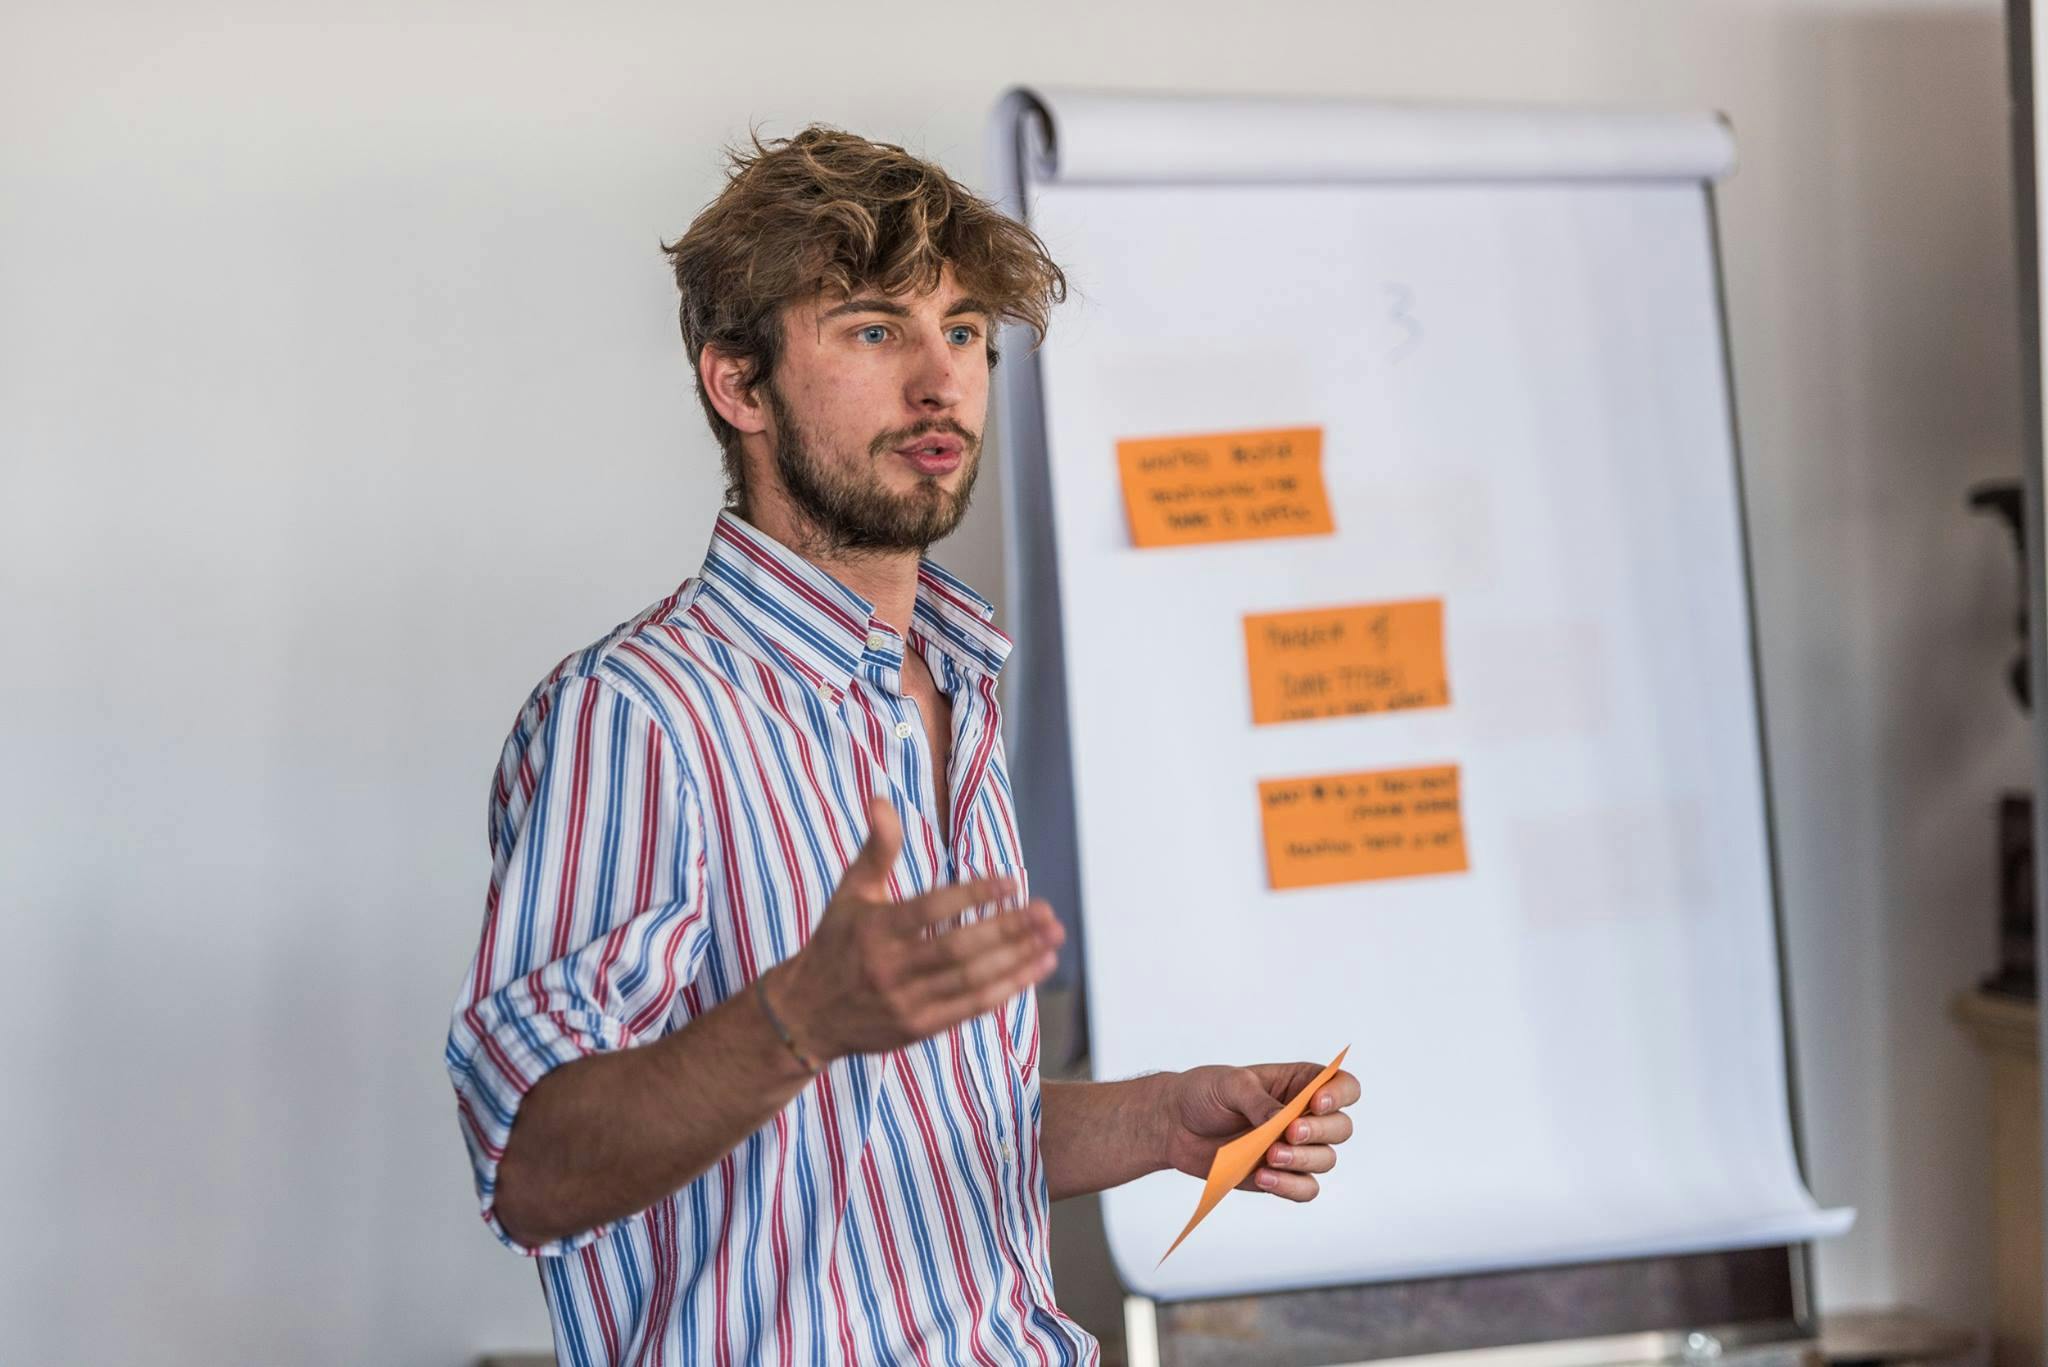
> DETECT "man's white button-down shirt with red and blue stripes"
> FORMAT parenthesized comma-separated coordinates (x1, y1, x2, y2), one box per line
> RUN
(446, 512, 1098, 1367)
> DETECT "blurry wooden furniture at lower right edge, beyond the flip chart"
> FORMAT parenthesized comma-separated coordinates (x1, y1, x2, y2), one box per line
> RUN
(1956, 992, 2044, 1367)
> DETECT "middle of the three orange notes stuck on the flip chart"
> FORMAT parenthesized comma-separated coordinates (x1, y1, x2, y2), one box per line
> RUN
(1245, 598, 1450, 726)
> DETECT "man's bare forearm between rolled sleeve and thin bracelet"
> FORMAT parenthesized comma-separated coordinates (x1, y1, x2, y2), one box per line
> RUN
(496, 969, 811, 1248)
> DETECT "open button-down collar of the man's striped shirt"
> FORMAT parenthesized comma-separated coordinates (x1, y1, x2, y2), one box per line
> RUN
(700, 508, 1010, 691)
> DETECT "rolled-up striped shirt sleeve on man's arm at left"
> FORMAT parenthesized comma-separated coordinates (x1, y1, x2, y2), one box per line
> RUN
(446, 674, 707, 1256)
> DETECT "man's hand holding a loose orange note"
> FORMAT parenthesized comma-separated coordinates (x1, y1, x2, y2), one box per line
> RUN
(1163, 1064, 1358, 1201)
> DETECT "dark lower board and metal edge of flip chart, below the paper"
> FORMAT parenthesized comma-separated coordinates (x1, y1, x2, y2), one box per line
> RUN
(1124, 1246, 1812, 1367)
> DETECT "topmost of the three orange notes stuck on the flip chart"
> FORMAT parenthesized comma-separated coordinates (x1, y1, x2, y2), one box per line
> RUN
(1116, 426, 1335, 547)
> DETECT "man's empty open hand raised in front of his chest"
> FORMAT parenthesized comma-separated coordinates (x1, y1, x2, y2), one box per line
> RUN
(770, 797, 1065, 1064)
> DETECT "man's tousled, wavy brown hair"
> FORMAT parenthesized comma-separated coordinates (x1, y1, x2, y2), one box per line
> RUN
(662, 123, 1067, 506)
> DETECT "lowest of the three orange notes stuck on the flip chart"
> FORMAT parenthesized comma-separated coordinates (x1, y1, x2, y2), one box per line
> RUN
(1260, 764, 1468, 892)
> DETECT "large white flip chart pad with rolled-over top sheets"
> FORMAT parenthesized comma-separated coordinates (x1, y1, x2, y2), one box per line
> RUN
(991, 92, 1849, 1299)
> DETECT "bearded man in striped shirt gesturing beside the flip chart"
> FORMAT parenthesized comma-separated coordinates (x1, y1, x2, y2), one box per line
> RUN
(446, 127, 1358, 1365)
